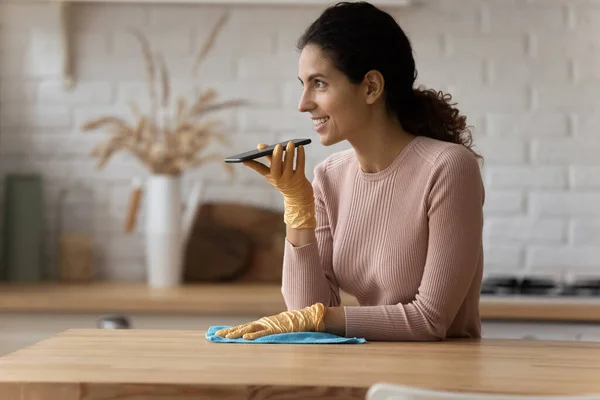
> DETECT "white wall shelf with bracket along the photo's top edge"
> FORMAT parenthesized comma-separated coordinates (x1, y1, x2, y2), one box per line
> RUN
(50, 0, 412, 90)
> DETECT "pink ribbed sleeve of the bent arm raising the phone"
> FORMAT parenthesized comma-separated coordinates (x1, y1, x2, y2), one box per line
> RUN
(281, 163, 340, 310)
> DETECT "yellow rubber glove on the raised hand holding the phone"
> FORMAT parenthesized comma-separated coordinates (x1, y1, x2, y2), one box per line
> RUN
(244, 141, 317, 229)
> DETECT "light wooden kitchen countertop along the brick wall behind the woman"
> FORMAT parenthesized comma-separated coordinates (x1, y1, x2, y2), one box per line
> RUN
(0, 282, 600, 322)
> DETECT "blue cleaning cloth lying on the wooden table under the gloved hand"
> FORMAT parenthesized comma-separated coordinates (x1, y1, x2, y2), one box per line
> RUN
(206, 326, 366, 344)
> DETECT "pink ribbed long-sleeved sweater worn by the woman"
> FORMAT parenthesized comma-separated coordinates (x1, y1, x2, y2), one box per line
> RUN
(281, 136, 484, 341)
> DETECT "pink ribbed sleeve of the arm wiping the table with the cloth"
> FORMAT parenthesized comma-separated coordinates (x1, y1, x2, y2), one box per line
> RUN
(344, 147, 484, 341)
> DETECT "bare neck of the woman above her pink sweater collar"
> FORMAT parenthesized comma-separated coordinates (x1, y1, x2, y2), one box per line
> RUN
(349, 114, 415, 173)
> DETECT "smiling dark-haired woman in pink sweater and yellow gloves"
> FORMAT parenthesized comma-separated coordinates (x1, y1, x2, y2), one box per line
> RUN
(217, 3, 484, 341)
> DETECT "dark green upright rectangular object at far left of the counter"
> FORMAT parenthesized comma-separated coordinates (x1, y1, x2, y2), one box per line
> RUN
(0, 174, 45, 282)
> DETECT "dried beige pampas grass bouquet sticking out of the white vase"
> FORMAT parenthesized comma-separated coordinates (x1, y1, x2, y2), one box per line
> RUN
(82, 15, 246, 175)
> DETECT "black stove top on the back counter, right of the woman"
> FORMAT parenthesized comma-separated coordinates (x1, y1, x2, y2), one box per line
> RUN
(481, 275, 600, 297)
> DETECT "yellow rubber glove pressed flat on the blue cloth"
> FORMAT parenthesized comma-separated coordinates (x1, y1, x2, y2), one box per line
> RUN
(215, 303, 326, 340)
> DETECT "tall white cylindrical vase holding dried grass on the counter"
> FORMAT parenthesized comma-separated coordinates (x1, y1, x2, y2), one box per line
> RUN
(145, 175, 184, 287)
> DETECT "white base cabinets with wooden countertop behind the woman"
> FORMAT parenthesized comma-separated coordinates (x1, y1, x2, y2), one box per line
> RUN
(0, 283, 600, 355)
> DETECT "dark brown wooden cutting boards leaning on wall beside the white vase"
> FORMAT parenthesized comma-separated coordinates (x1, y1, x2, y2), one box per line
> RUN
(184, 202, 285, 283)
